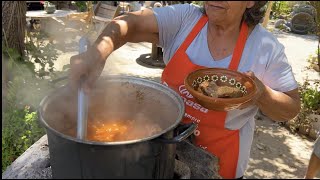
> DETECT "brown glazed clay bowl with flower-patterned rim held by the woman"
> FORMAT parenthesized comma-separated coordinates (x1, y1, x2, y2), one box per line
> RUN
(184, 68, 257, 111)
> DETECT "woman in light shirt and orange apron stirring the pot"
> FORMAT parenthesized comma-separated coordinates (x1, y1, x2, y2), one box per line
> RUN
(70, 1, 300, 178)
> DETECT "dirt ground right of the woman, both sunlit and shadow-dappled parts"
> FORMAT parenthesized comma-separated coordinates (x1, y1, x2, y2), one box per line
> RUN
(245, 25, 320, 179)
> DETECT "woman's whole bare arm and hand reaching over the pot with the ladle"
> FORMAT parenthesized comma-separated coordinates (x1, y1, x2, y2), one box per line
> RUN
(69, 9, 159, 93)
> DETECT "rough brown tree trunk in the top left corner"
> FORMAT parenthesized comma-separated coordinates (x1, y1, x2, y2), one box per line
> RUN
(2, 1, 27, 55)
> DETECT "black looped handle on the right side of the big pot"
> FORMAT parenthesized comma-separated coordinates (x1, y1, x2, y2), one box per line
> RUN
(157, 123, 198, 144)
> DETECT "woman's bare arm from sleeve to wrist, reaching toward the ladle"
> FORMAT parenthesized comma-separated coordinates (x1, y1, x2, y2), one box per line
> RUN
(93, 9, 159, 60)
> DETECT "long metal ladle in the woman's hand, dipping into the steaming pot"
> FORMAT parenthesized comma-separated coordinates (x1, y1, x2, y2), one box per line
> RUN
(77, 38, 88, 140)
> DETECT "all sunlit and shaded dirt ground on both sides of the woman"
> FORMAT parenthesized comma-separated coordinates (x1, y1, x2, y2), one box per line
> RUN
(48, 20, 320, 179)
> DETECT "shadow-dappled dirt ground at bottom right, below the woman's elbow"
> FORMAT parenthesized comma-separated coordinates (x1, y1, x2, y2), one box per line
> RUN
(245, 116, 313, 179)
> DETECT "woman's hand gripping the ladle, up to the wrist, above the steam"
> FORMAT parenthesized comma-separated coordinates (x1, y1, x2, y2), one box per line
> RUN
(69, 46, 106, 93)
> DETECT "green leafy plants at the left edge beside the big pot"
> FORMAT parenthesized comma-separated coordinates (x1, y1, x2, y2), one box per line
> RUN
(2, 50, 52, 172)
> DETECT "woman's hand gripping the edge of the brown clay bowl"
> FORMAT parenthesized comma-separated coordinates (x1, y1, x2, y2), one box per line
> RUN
(238, 71, 266, 109)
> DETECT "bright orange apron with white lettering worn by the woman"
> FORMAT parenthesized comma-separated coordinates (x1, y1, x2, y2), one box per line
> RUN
(161, 16, 248, 178)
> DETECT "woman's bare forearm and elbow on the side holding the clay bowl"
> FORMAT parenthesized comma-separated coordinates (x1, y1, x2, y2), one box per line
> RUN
(257, 86, 300, 121)
